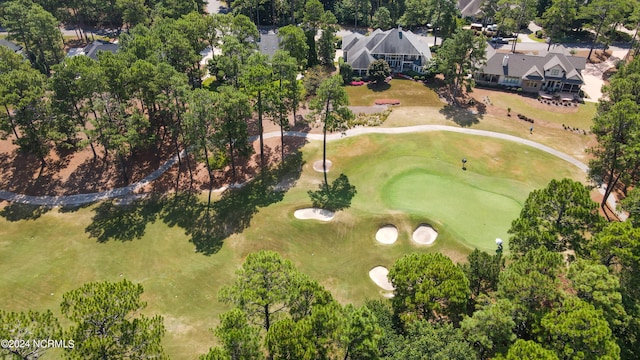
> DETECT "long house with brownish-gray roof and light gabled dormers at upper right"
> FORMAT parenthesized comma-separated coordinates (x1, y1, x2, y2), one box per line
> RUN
(475, 46, 587, 93)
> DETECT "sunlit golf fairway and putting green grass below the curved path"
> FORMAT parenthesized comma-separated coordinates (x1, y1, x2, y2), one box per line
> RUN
(0, 132, 581, 359)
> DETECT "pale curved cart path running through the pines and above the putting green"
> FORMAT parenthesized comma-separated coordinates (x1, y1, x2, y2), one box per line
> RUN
(0, 125, 588, 206)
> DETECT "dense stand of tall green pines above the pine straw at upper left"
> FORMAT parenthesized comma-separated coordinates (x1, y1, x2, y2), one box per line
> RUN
(0, 0, 336, 188)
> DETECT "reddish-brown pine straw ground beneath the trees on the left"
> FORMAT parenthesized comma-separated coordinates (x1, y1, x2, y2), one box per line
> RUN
(0, 116, 319, 196)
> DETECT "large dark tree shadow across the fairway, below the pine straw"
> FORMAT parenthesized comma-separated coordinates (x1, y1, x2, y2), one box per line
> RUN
(85, 151, 302, 255)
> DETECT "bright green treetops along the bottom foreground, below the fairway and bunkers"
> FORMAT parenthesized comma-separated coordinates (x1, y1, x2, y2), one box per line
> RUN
(5, 179, 640, 360)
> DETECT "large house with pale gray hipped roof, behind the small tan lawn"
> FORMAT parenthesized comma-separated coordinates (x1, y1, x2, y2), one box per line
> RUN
(342, 28, 431, 75)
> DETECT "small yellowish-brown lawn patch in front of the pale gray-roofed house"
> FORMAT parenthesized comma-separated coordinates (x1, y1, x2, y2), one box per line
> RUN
(346, 79, 443, 107)
